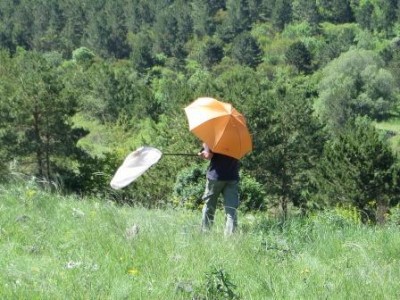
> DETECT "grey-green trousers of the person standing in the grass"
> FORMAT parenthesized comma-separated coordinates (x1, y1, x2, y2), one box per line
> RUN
(202, 179, 239, 235)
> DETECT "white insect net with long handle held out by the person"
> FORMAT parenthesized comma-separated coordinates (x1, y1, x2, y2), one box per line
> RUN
(110, 146, 196, 190)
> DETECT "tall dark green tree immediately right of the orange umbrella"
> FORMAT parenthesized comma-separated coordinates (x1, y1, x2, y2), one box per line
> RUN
(246, 75, 324, 217)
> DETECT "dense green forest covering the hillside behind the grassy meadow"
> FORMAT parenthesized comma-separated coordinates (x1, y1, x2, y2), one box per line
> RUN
(0, 0, 400, 222)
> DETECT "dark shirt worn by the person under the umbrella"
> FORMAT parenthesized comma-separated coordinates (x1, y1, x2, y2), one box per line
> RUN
(207, 153, 239, 180)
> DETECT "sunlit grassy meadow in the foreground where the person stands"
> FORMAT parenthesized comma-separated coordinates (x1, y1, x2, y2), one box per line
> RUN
(0, 183, 400, 299)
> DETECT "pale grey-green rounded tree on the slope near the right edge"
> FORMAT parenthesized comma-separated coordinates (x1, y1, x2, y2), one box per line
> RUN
(316, 50, 398, 131)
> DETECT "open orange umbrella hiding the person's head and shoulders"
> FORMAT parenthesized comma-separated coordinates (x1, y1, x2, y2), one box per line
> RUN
(185, 97, 252, 159)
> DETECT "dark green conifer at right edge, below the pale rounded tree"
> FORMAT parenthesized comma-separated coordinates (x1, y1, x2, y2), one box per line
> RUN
(317, 117, 399, 222)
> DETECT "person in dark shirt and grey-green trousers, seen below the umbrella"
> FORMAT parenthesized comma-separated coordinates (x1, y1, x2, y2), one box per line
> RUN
(198, 144, 239, 235)
